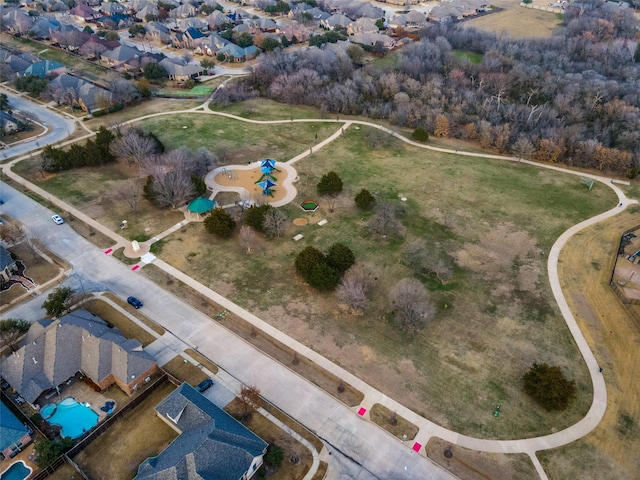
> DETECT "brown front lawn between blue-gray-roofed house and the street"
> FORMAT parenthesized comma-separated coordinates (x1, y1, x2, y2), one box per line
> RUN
(224, 398, 313, 480)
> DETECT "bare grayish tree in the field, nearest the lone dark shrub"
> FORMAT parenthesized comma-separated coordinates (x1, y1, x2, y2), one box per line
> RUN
(389, 278, 435, 332)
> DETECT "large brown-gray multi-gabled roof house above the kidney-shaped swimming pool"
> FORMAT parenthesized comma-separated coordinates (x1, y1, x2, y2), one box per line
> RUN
(0, 309, 159, 404)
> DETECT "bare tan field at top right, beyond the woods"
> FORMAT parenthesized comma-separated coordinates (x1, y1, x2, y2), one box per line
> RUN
(461, 0, 562, 38)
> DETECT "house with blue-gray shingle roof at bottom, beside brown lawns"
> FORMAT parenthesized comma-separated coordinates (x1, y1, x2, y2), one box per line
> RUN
(134, 383, 267, 480)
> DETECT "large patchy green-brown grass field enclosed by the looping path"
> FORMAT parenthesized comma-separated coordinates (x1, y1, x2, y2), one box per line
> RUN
(152, 121, 615, 438)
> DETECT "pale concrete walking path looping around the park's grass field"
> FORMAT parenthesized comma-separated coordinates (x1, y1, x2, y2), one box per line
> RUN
(2, 94, 637, 479)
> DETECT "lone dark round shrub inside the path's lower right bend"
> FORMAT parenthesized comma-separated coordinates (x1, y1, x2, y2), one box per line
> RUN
(522, 363, 576, 411)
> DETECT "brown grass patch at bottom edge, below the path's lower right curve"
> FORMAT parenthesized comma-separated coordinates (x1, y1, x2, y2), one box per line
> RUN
(425, 437, 536, 480)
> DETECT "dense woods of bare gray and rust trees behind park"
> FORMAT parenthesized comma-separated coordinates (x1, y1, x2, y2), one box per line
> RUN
(222, 0, 640, 178)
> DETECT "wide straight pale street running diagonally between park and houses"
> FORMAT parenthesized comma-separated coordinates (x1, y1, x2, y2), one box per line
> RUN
(0, 184, 453, 480)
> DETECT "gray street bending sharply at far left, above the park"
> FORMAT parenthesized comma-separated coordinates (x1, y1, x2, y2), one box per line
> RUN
(0, 85, 75, 160)
